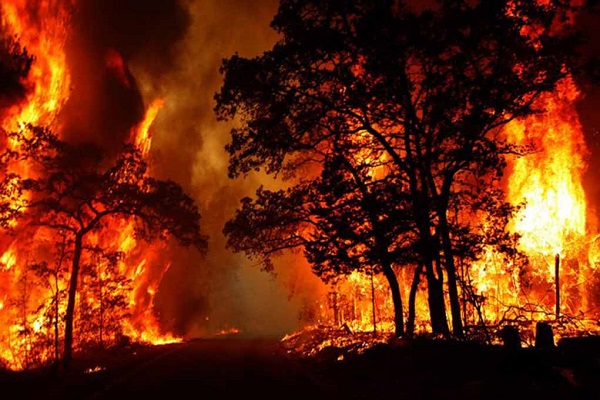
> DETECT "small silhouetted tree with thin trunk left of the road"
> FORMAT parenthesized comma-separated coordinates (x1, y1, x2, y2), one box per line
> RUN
(0, 126, 207, 368)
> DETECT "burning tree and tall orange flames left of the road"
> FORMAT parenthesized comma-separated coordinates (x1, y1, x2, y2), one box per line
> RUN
(0, 0, 212, 369)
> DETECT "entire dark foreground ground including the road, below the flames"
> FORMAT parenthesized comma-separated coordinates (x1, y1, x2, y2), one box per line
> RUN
(0, 337, 600, 400)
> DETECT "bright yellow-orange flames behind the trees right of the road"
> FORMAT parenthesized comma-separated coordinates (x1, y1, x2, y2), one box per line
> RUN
(312, 77, 599, 343)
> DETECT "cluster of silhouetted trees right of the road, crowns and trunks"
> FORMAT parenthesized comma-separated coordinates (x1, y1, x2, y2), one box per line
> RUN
(215, 0, 592, 336)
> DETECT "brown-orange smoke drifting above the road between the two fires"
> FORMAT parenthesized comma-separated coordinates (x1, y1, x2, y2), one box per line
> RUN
(62, 0, 320, 336)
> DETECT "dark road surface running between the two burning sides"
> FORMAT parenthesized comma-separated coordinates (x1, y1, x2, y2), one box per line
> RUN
(24, 338, 352, 400)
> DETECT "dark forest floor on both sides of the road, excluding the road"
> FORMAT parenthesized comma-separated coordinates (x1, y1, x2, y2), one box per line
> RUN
(0, 329, 600, 400)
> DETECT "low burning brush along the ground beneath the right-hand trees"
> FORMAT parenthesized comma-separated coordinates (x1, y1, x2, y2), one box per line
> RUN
(282, 273, 600, 359)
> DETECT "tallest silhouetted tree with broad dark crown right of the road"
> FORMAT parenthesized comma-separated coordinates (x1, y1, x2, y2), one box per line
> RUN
(215, 0, 578, 336)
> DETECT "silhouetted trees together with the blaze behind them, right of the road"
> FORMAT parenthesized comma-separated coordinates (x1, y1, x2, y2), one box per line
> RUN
(215, 0, 600, 354)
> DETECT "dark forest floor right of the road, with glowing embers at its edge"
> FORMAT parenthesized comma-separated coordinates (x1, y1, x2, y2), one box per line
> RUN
(283, 329, 600, 400)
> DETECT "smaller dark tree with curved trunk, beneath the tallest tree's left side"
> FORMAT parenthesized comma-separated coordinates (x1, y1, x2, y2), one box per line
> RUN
(224, 157, 411, 335)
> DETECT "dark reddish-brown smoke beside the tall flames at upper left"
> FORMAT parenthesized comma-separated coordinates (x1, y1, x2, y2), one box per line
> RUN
(64, 0, 189, 155)
